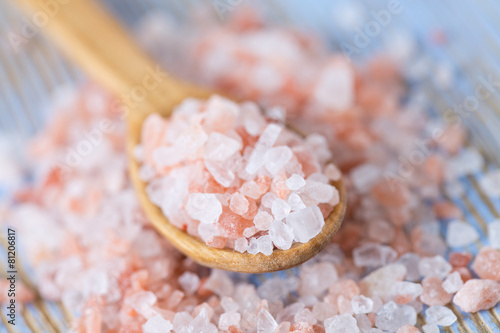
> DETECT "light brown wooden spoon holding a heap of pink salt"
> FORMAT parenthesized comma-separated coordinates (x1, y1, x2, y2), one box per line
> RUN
(14, 0, 346, 273)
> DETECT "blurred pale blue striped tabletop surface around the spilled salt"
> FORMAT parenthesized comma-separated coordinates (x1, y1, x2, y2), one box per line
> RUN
(0, 0, 500, 332)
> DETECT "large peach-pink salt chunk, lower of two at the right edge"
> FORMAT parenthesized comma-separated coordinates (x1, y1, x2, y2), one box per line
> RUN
(453, 279, 500, 312)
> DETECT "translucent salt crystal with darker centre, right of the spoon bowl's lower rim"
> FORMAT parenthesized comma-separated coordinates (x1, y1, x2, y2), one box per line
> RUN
(353, 243, 398, 267)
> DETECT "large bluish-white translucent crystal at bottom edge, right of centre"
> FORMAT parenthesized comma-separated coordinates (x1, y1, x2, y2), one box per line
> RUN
(375, 301, 417, 332)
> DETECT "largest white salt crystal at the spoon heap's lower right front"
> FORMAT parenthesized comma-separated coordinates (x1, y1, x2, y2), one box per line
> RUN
(286, 206, 325, 243)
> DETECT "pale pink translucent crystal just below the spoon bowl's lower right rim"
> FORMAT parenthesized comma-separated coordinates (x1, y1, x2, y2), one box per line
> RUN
(299, 262, 338, 296)
